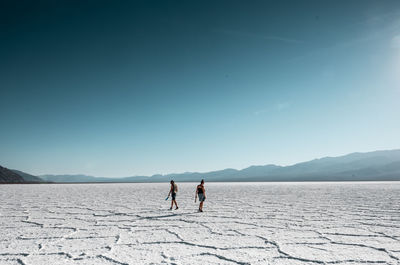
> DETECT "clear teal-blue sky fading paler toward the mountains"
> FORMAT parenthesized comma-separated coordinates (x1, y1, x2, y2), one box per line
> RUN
(0, 0, 400, 177)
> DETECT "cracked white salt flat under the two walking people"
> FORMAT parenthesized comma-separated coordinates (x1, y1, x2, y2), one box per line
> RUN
(0, 182, 400, 265)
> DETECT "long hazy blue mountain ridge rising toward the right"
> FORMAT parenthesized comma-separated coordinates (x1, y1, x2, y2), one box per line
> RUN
(40, 149, 400, 182)
